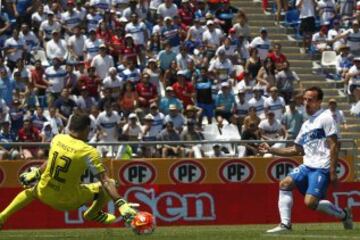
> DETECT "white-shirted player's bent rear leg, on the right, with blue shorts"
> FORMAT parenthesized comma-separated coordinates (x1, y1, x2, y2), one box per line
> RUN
(305, 169, 353, 229)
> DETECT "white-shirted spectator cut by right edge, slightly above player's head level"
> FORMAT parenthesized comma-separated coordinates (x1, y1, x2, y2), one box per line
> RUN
(345, 57, 360, 102)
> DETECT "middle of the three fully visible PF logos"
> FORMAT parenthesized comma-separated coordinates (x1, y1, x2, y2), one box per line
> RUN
(170, 160, 205, 183)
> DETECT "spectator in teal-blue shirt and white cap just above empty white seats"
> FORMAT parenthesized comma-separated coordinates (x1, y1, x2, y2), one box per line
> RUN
(215, 82, 236, 122)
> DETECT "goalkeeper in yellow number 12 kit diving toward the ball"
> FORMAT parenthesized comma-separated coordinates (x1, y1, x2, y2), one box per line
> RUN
(0, 114, 136, 228)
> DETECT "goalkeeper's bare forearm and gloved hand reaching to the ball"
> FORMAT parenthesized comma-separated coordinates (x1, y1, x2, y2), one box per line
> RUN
(100, 172, 136, 223)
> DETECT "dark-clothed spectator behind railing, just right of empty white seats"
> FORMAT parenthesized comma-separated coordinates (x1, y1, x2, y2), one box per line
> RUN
(241, 121, 260, 156)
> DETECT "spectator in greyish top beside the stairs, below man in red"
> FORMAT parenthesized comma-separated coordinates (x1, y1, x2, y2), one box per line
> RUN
(275, 60, 300, 104)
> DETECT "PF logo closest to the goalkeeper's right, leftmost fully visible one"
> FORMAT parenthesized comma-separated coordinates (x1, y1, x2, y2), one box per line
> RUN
(119, 161, 156, 185)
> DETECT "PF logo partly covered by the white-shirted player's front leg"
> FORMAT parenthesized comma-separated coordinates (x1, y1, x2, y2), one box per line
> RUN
(267, 158, 299, 182)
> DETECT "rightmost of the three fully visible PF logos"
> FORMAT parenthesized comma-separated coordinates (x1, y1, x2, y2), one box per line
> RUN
(219, 160, 254, 183)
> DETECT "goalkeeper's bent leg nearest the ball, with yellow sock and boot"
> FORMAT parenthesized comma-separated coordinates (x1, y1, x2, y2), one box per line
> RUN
(81, 181, 116, 224)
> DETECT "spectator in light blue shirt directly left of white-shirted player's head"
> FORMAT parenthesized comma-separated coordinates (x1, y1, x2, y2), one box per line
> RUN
(282, 99, 304, 140)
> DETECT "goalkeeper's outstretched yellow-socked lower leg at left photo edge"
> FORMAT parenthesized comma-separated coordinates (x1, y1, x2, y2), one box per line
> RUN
(0, 188, 35, 225)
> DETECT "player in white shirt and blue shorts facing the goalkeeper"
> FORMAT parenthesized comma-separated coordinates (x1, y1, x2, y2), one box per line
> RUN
(259, 87, 353, 233)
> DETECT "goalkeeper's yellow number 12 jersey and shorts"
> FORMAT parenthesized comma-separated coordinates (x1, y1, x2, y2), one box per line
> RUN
(36, 134, 105, 209)
